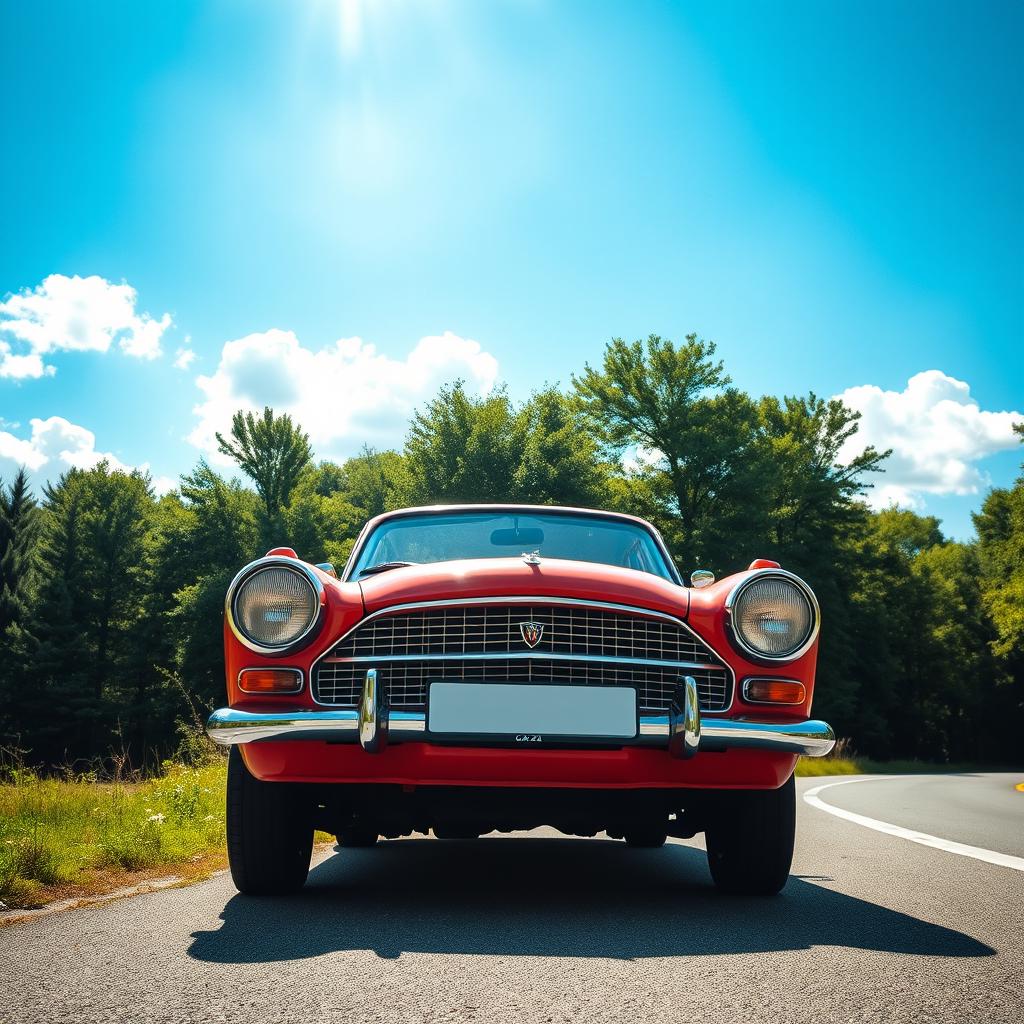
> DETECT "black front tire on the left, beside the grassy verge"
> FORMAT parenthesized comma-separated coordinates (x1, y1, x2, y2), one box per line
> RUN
(227, 746, 313, 896)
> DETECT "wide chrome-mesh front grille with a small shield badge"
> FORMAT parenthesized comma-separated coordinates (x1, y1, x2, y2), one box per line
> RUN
(312, 603, 732, 713)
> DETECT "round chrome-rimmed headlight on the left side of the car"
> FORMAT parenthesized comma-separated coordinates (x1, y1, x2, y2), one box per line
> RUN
(227, 559, 323, 653)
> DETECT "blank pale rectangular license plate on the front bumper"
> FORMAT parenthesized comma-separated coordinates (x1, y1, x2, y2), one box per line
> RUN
(427, 682, 637, 739)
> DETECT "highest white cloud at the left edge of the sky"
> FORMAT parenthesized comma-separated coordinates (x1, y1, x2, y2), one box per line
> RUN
(0, 273, 171, 379)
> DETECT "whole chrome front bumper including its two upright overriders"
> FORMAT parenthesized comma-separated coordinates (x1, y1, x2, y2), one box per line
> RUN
(206, 670, 836, 758)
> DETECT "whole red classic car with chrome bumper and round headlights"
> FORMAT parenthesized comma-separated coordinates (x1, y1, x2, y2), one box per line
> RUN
(208, 505, 835, 894)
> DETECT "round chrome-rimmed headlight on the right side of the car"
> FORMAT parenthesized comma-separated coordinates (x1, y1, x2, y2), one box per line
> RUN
(726, 570, 819, 662)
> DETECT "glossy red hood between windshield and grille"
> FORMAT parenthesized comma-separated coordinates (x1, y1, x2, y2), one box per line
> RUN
(359, 557, 689, 618)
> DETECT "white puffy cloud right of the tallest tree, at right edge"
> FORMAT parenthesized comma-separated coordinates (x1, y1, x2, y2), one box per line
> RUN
(838, 370, 1024, 508)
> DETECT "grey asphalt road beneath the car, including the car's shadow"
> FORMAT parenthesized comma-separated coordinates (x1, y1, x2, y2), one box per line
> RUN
(0, 773, 1024, 1024)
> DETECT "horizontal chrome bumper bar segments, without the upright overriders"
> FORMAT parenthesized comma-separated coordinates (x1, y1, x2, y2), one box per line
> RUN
(206, 708, 836, 758)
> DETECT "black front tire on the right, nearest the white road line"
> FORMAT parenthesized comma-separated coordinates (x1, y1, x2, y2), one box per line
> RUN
(705, 775, 797, 896)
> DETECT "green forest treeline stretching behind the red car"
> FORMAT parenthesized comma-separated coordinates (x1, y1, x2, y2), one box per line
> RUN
(0, 336, 1024, 764)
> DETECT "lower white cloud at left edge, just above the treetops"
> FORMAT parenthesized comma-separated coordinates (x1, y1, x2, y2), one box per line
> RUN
(0, 416, 160, 498)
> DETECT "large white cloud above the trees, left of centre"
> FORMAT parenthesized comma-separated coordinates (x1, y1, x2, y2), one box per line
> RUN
(188, 330, 498, 463)
